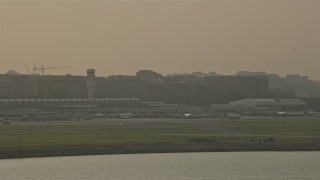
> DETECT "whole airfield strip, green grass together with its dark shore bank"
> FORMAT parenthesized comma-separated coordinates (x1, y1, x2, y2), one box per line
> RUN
(0, 117, 320, 159)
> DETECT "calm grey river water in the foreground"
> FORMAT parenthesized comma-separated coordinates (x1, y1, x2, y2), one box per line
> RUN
(0, 152, 320, 180)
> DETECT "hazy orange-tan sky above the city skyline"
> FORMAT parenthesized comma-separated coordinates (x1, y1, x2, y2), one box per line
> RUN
(0, 0, 320, 80)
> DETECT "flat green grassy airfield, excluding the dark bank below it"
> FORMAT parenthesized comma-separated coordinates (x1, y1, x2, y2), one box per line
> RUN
(0, 118, 320, 158)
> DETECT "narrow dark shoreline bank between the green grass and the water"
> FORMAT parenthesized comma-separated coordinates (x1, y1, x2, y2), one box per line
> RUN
(0, 143, 320, 159)
